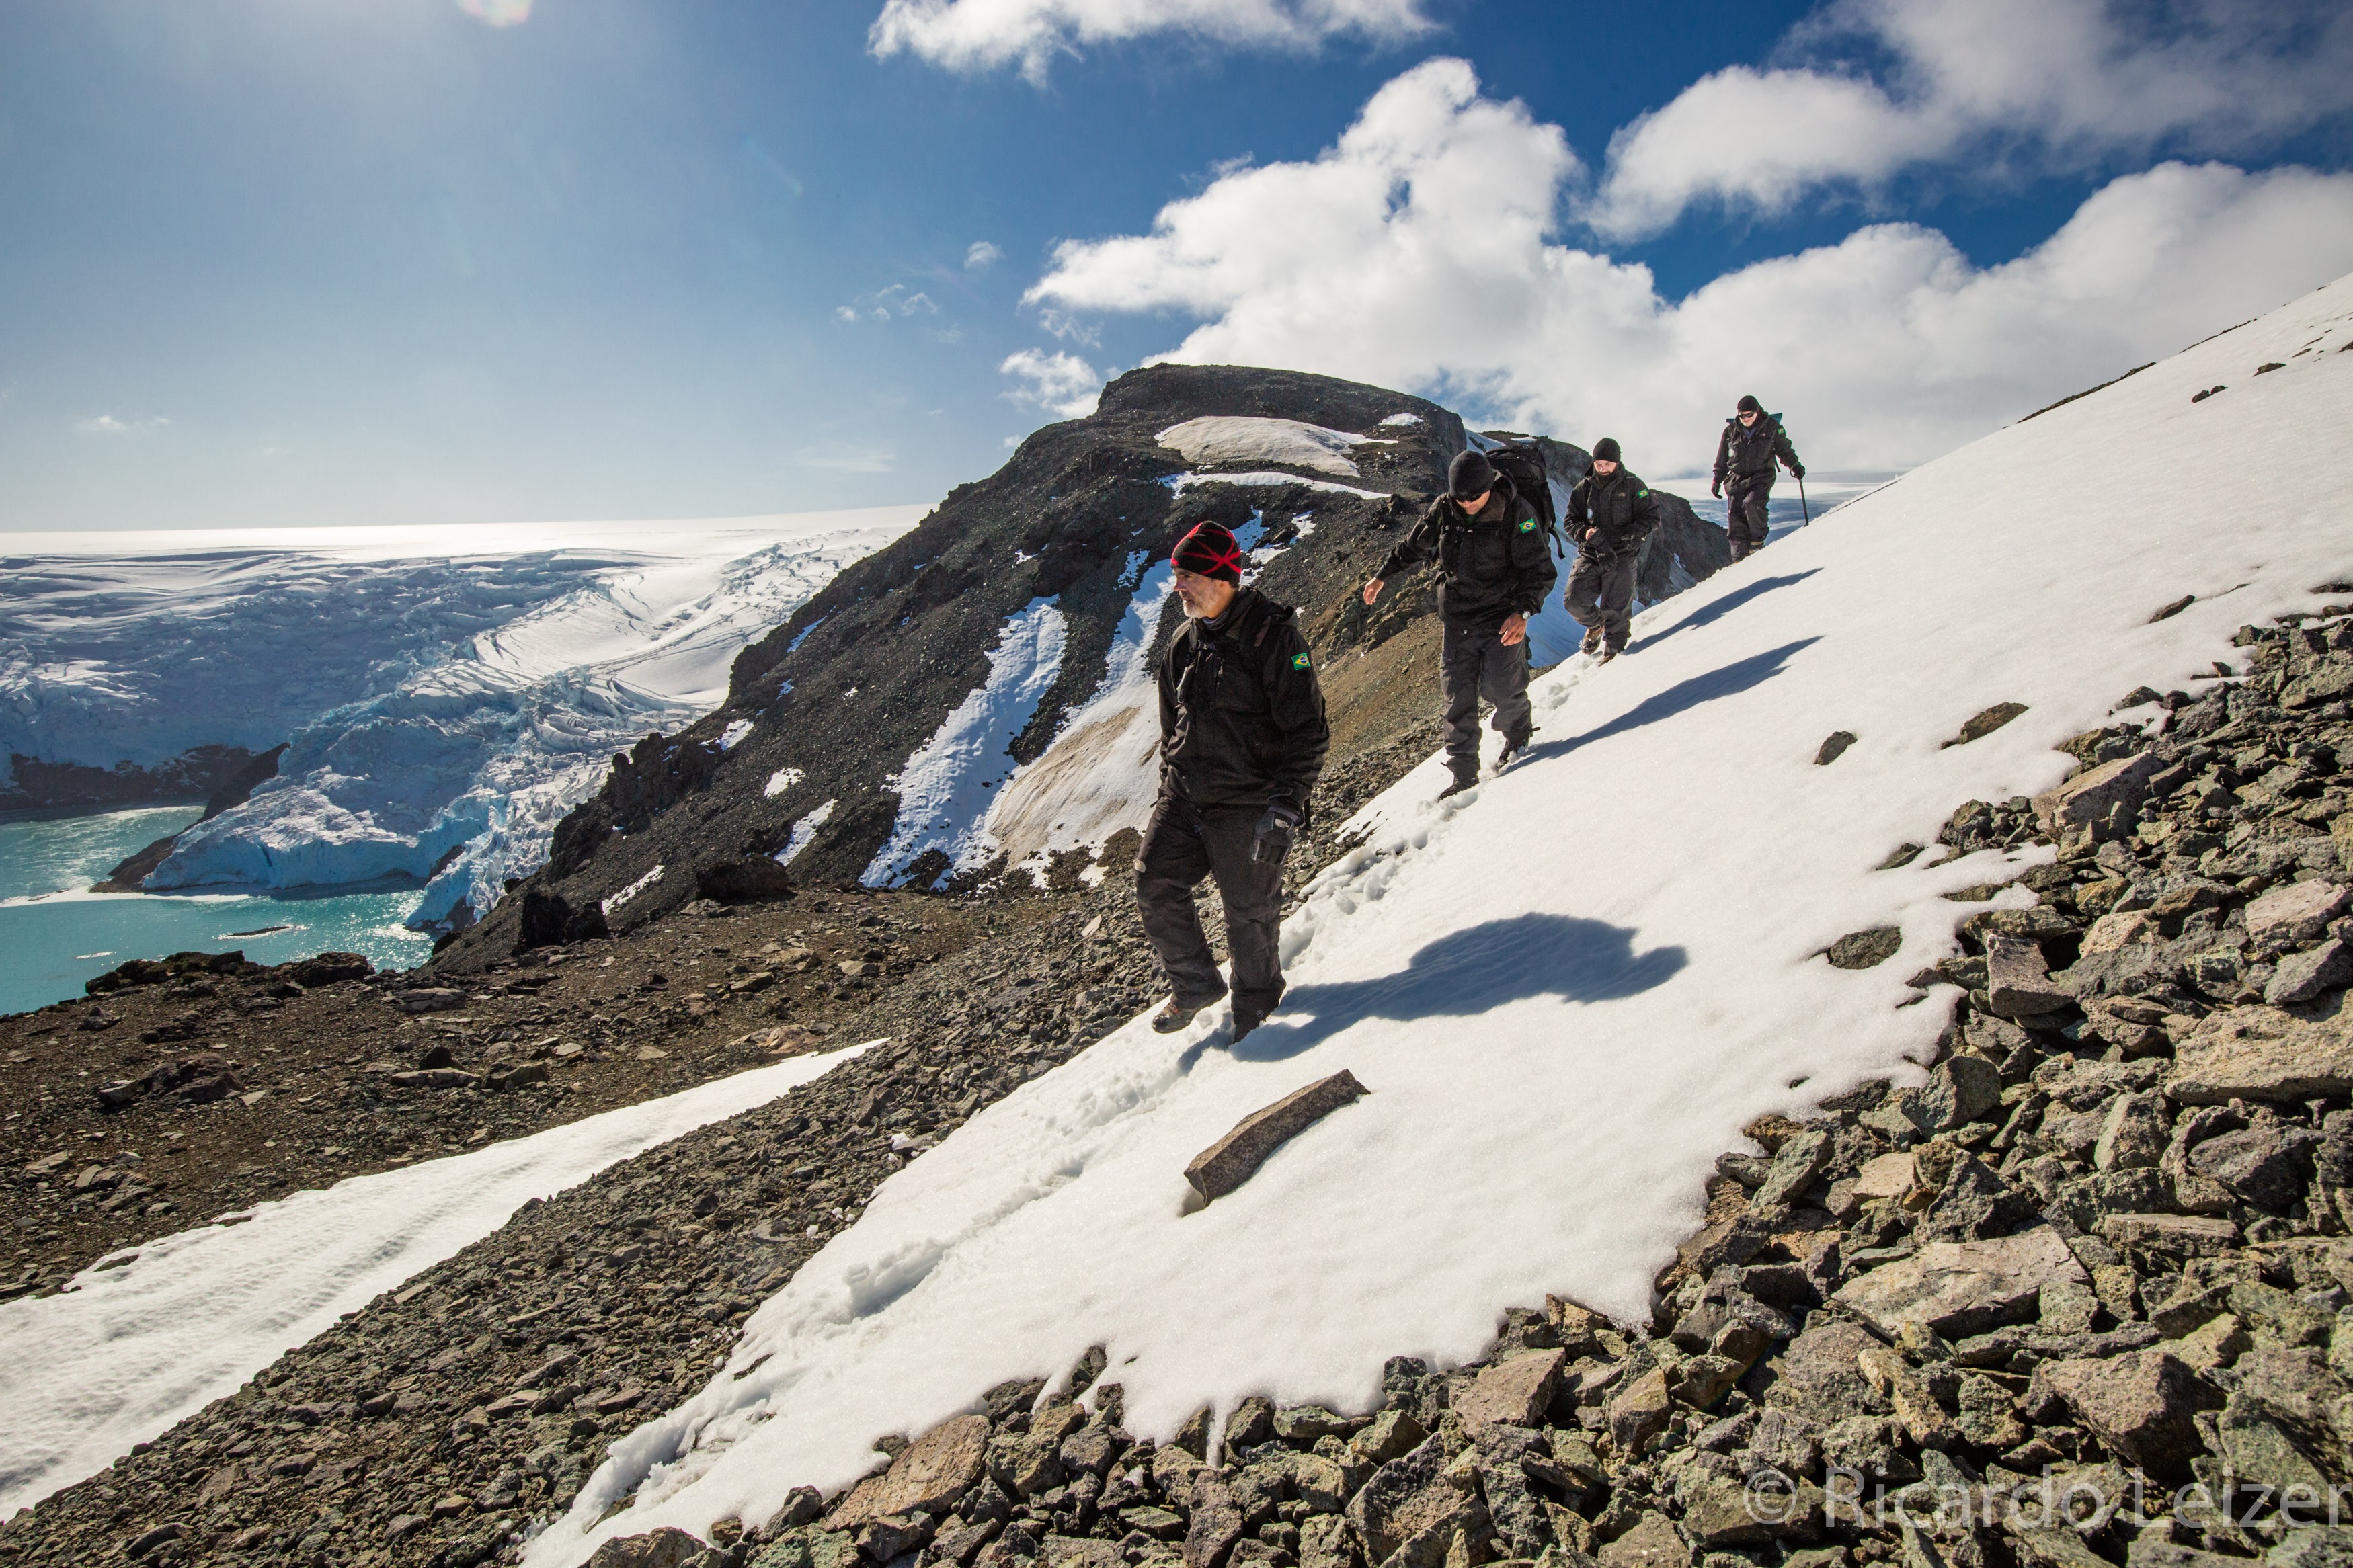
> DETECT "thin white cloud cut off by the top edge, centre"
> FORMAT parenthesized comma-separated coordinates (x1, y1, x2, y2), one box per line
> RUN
(866, 0, 1435, 82)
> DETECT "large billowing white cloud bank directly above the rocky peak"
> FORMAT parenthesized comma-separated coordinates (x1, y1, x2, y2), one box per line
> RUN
(1035, 58, 2353, 477)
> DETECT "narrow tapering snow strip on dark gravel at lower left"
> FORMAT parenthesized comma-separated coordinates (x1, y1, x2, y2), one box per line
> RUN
(0, 1046, 866, 1516)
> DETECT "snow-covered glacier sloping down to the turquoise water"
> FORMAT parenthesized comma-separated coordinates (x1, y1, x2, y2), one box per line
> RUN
(0, 505, 925, 929)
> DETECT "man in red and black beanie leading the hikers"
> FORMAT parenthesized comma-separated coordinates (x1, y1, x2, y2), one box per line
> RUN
(1137, 522, 1332, 1039)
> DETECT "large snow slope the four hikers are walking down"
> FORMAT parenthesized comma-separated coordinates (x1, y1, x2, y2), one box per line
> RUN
(525, 280, 2353, 1568)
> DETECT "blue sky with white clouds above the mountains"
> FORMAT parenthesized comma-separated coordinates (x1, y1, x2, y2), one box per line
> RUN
(0, 0, 2353, 529)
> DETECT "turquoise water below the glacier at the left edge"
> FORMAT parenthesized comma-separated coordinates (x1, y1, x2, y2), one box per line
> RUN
(0, 807, 433, 1014)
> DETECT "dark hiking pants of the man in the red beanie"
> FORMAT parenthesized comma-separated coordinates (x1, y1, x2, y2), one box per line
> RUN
(1137, 794, 1283, 1018)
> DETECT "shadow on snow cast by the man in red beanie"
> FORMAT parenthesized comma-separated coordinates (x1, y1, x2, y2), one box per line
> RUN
(1233, 915, 1687, 1063)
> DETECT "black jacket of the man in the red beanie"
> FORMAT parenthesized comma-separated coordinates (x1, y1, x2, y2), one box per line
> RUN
(1160, 587, 1332, 816)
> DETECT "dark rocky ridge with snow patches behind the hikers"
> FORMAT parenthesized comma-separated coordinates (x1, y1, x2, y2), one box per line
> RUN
(436, 364, 1730, 973)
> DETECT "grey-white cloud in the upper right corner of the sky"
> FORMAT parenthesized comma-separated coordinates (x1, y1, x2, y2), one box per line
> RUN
(1579, 0, 2353, 237)
